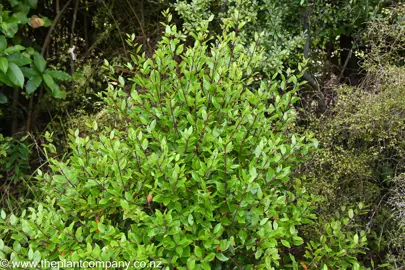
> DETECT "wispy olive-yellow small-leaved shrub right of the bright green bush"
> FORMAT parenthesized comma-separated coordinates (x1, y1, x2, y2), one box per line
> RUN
(306, 5, 405, 269)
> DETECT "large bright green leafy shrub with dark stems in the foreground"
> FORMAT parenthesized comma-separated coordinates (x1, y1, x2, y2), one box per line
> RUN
(0, 15, 363, 269)
